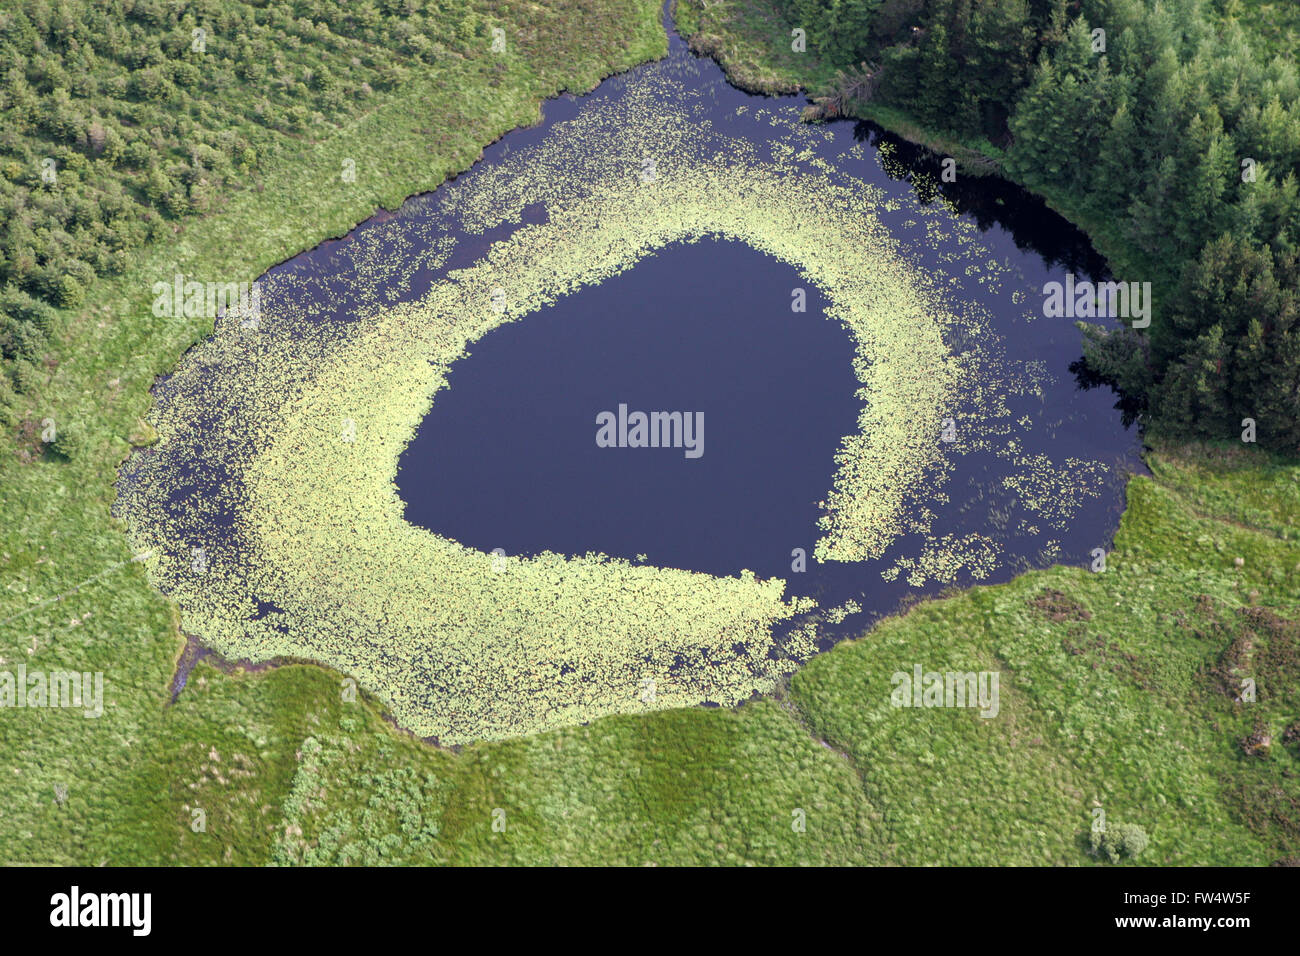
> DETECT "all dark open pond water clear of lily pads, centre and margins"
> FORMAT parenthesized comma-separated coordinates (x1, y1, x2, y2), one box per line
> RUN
(131, 5, 1143, 650)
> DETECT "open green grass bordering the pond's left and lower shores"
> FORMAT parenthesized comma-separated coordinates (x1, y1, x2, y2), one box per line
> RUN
(0, 3, 1300, 865)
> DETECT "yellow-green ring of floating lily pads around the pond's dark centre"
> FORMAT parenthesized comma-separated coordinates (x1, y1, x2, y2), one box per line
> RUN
(117, 52, 1102, 744)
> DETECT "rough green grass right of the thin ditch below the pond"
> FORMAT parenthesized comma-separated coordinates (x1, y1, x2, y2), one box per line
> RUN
(793, 450, 1300, 865)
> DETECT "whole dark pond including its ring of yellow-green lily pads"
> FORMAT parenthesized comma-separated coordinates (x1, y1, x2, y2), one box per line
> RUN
(117, 3, 1141, 743)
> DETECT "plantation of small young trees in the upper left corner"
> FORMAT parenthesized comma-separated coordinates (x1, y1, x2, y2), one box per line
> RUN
(0, 0, 489, 424)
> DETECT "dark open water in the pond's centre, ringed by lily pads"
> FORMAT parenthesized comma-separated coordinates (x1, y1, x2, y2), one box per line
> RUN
(398, 241, 858, 578)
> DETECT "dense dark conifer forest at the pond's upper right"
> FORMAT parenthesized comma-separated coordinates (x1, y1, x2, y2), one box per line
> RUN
(781, 0, 1300, 454)
